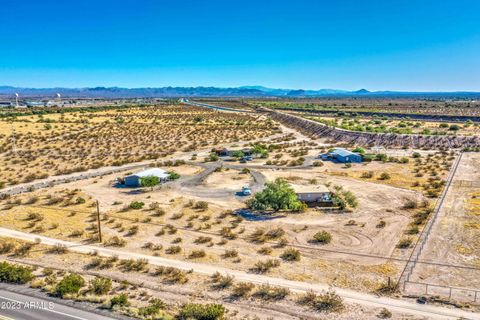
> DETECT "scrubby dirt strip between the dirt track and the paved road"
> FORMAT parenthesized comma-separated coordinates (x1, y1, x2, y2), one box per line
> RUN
(0, 238, 420, 320)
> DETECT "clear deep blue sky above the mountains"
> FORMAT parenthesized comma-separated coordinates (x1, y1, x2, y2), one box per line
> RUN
(0, 0, 480, 91)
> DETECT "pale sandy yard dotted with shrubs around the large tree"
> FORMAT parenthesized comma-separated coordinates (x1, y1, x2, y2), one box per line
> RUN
(3, 156, 423, 291)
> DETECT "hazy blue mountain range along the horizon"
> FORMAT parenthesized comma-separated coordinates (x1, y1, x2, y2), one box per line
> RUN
(0, 86, 480, 98)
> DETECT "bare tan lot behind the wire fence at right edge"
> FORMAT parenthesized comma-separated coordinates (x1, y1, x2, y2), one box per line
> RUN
(411, 153, 480, 297)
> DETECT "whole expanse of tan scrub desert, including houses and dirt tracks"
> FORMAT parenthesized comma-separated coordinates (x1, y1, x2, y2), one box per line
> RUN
(0, 100, 478, 319)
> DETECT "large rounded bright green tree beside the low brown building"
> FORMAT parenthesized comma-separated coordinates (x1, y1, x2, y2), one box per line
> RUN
(247, 178, 306, 211)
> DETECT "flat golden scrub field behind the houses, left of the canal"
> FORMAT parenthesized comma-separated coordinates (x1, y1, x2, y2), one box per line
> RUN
(0, 105, 281, 187)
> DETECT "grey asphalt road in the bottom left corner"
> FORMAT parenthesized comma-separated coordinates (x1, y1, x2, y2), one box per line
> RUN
(0, 289, 115, 320)
